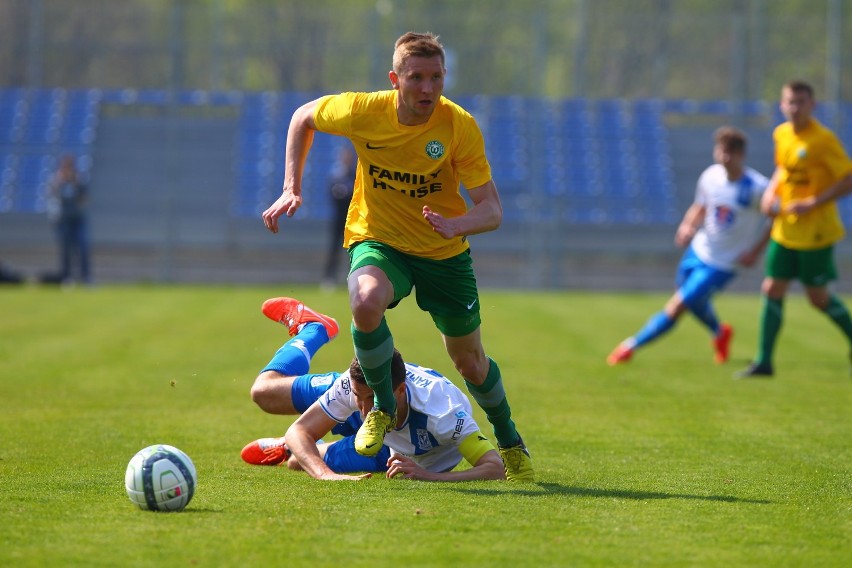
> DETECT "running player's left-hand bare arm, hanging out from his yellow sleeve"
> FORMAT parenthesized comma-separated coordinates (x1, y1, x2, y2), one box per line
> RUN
(261, 99, 319, 233)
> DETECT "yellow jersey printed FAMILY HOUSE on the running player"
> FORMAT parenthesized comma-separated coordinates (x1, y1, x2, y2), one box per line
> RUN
(314, 89, 491, 260)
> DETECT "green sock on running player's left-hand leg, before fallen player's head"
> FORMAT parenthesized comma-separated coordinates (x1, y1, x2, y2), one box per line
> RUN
(352, 318, 396, 414)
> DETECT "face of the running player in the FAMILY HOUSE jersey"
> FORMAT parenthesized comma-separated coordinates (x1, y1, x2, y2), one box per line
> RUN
(388, 55, 446, 126)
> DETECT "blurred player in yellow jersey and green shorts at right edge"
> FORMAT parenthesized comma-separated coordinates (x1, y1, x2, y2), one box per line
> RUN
(737, 81, 852, 378)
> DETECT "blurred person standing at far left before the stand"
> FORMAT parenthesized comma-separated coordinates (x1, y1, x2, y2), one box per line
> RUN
(47, 154, 91, 284)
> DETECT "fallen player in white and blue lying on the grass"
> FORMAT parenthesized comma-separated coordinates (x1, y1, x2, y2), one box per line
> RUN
(241, 298, 505, 481)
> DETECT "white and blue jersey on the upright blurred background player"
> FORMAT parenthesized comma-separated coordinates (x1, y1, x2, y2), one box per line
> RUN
(690, 164, 769, 272)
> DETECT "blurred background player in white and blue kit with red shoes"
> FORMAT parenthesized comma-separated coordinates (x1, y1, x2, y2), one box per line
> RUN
(607, 126, 769, 365)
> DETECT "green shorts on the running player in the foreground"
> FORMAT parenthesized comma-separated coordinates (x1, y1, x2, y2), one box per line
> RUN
(349, 241, 481, 337)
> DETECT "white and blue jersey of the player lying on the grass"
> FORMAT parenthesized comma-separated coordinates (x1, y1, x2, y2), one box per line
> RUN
(319, 363, 479, 472)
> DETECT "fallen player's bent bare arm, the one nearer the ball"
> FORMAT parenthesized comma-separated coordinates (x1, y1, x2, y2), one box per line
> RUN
(284, 402, 372, 481)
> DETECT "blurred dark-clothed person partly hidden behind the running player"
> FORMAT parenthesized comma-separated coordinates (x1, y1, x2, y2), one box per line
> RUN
(322, 144, 357, 288)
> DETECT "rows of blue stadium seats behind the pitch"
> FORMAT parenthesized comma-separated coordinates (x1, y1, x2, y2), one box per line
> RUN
(0, 89, 852, 225)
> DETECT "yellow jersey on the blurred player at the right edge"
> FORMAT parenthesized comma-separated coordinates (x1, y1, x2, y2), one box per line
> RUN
(772, 119, 852, 250)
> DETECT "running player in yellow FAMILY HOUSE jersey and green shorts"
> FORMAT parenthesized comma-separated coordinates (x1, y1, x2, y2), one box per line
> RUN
(262, 32, 534, 481)
